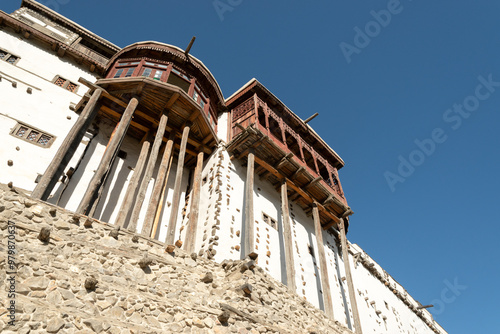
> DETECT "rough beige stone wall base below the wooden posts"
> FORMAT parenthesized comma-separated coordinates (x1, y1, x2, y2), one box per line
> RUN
(0, 185, 352, 334)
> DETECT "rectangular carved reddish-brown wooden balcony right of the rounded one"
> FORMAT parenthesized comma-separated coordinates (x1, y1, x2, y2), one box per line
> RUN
(228, 94, 350, 225)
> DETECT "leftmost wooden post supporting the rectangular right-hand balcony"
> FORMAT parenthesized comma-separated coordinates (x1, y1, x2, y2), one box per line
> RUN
(241, 149, 255, 258)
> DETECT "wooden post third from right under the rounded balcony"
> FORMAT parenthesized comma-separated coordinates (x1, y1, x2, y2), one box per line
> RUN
(141, 132, 174, 238)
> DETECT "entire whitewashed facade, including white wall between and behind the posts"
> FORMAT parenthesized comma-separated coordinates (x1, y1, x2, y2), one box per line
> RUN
(0, 0, 446, 334)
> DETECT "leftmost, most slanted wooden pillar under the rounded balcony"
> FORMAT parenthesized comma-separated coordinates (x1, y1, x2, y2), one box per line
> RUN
(31, 88, 103, 201)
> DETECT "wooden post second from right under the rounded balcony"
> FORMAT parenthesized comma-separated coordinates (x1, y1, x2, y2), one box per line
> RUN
(165, 124, 191, 245)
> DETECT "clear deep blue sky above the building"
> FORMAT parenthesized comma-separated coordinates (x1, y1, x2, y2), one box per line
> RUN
(1, 0, 500, 334)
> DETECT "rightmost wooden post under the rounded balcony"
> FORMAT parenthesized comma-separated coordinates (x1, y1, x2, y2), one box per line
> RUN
(184, 147, 204, 253)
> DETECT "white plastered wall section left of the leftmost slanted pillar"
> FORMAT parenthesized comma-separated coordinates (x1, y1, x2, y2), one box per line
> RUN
(0, 28, 96, 191)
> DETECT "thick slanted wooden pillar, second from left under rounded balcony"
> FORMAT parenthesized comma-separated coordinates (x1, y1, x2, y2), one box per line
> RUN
(76, 98, 139, 214)
